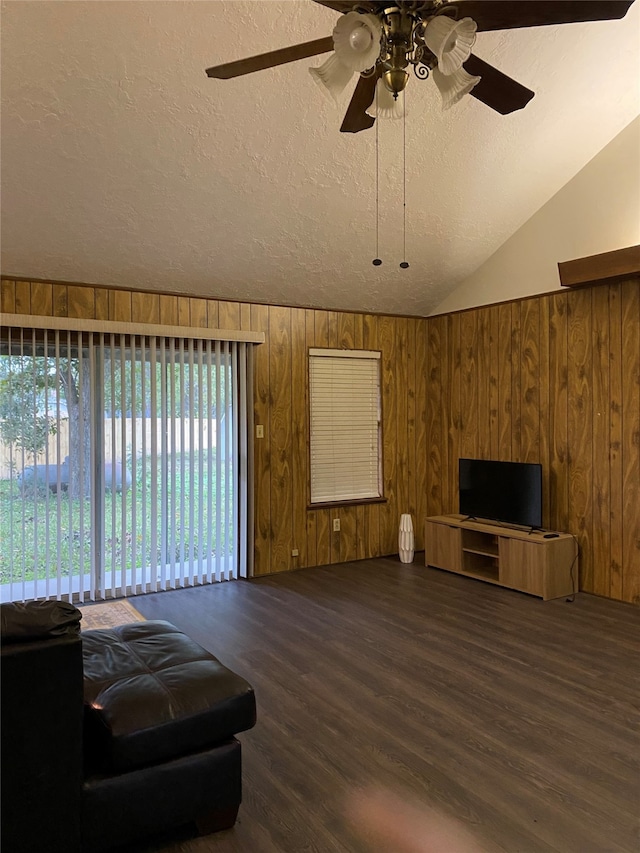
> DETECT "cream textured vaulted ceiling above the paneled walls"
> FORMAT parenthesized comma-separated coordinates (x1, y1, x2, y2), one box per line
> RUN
(1, 0, 640, 315)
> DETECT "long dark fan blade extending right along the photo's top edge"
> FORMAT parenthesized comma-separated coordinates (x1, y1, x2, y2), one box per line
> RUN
(454, 0, 633, 31)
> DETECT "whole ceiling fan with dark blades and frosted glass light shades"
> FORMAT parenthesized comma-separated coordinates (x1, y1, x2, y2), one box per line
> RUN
(207, 0, 633, 133)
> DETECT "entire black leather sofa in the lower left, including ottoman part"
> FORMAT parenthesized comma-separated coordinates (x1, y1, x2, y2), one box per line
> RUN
(0, 601, 256, 853)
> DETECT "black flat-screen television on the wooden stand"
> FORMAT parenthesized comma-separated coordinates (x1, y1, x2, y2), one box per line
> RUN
(459, 459, 542, 527)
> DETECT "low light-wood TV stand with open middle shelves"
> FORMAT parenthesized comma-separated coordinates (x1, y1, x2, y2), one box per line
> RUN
(425, 515, 578, 601)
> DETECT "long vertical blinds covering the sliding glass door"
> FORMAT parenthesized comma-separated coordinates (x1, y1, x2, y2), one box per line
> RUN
(0, 328, 252, 601)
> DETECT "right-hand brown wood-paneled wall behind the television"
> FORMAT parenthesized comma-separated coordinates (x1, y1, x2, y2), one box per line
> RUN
(426, 278, 640, 603)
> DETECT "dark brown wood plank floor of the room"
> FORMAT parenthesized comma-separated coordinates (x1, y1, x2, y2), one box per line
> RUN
(133, 554, 640, 853)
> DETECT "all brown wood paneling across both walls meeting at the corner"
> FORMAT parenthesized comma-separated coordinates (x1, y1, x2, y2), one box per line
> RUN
(1, 279, 640, 602)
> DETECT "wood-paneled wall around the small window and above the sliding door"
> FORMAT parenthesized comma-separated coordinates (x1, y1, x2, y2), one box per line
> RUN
(1, 280, 427, 574)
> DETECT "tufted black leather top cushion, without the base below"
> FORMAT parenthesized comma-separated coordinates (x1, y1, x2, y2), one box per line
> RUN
(82, 622, 256, 772)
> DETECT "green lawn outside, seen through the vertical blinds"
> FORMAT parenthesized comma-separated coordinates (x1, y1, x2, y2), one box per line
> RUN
(0, 451, 232, 584)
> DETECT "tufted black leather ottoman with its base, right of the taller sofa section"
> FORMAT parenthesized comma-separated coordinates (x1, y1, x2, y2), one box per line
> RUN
(82, 622, 256, 851)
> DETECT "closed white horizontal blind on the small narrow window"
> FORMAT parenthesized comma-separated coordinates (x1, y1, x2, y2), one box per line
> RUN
(309, 349, 381, 503)
